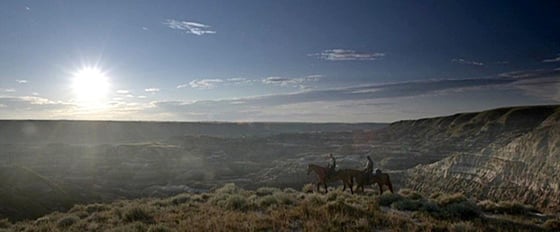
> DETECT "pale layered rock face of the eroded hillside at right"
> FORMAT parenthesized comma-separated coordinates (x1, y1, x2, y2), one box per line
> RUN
(406, 106, 560, 211)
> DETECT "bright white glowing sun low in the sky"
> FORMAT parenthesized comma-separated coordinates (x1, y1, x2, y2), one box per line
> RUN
(72, 67, 110, 108)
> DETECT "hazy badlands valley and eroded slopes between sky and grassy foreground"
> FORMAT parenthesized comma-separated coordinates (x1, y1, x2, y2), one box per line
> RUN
(0, 106, 560, 225)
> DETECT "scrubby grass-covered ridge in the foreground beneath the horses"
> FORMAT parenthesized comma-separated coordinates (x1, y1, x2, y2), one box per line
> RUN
(0, 184, 560, 231)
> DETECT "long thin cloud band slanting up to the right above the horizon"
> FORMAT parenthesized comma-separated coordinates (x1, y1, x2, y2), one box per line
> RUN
(153, 70, 560, 120)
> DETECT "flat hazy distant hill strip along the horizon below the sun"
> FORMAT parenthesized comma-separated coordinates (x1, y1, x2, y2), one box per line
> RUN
(0, 120, 386, 144)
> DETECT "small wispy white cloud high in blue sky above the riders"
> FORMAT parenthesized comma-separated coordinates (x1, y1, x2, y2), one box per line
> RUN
(309, 48, 385, 61)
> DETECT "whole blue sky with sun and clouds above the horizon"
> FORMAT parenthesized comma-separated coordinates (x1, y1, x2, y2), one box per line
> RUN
(0, 0, 560, 122)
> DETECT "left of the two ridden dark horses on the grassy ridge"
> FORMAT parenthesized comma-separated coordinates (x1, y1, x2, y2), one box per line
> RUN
(307, 164, 354, 193)
